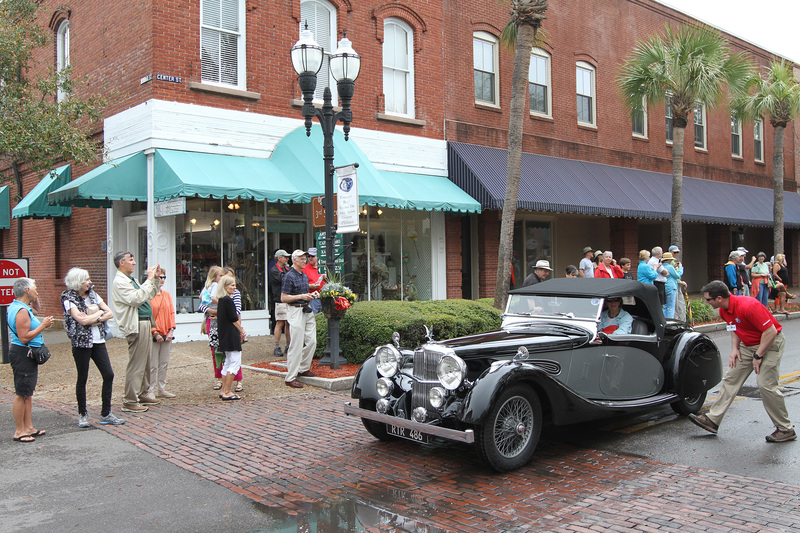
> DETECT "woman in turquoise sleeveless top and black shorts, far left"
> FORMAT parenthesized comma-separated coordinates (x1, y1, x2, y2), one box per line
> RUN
(7, 278, 53, 442)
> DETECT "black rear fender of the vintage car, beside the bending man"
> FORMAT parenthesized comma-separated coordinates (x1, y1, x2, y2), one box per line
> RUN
(671, 331, 722, 398)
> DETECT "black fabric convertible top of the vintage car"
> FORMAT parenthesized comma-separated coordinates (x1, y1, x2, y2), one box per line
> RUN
(509, 278, 666, 337)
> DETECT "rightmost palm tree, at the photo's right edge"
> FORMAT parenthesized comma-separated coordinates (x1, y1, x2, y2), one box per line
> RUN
(733, 59, 800, 254)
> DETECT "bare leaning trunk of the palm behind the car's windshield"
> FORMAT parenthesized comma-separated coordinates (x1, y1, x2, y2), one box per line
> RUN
(494, 24, 536, 310)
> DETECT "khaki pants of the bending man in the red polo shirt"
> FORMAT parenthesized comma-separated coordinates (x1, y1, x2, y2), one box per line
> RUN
(707, 332, 794, 430)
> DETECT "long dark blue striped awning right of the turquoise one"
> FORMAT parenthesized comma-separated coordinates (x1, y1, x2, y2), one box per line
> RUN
(447, 142, 800, 227)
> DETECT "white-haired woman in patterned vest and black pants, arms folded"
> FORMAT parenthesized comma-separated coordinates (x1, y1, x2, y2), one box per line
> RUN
(61, 268, 125, 428)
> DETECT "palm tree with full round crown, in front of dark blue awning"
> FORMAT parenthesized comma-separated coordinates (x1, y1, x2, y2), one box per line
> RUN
(617, 25, 752, 255)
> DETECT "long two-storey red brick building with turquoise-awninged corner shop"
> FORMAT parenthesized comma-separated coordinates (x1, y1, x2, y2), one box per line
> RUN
(0, 0, 800, 339)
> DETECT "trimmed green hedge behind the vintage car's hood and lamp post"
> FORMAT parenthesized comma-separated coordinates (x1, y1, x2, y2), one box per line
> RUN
(315, 300, 501, 364)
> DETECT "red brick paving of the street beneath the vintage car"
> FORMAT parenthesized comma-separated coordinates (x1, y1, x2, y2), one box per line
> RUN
(31, 393, 800, 533)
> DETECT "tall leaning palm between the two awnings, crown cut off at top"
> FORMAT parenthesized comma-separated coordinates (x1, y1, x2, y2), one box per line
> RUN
(494, 0, 547, 309)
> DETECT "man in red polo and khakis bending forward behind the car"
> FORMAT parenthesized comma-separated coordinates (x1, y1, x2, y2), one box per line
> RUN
(689, 281, 797, 442)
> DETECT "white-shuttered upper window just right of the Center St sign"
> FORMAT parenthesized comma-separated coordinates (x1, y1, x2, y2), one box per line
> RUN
(200, 0, 246, 89)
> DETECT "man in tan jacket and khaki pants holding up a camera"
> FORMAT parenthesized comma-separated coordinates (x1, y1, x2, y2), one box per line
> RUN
(111, 252, 161, 413)
